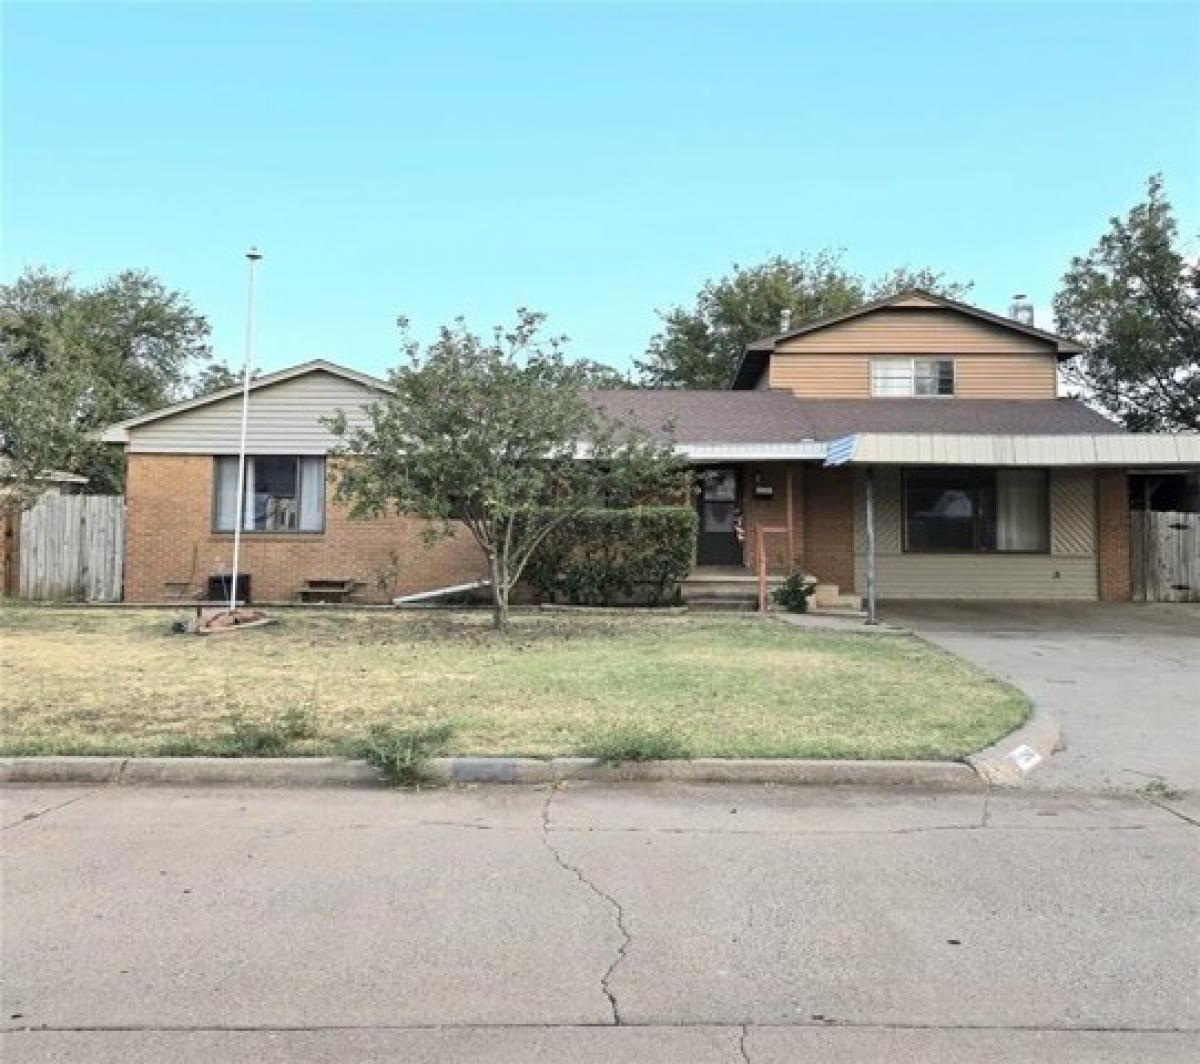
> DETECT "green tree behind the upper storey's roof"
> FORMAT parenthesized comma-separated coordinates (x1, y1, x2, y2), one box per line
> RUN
(636, 251, 971, 389)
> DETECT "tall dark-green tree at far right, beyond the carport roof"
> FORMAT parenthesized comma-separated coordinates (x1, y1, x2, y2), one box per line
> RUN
(1054, 174, 1200, 432)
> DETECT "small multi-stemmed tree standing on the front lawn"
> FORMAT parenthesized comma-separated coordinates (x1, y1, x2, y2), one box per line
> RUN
(330, 309, 686, 630)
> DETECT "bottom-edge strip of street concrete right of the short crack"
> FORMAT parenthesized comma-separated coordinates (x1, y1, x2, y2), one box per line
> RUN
(745, 1027, 1200, 1064)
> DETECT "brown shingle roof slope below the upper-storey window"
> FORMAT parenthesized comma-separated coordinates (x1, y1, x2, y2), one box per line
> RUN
(589, 389, 1123, 444)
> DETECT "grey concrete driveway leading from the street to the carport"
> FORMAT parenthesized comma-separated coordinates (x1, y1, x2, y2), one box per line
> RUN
(881, 602, 1200, 791)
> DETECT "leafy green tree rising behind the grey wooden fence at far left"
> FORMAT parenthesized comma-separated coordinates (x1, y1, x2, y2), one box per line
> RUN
(0, 269, 209, 494)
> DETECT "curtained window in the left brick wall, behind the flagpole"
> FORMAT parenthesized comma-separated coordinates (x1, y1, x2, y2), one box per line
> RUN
(212, 455, 325, 533)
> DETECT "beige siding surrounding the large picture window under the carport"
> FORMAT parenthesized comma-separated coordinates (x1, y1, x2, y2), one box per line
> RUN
(854, 469, 1099, 601)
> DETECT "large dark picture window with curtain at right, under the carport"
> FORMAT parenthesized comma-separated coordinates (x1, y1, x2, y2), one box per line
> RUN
(904, 469, 1050, 553)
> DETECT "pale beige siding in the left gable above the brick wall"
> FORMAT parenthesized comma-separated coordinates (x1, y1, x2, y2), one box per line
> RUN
(128, 372, 377, 455)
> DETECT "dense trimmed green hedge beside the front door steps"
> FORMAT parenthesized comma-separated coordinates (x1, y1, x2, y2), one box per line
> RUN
(526, 506, 697, 606)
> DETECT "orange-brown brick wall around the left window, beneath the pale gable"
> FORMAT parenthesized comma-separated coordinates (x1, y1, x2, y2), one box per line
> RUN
(125, 455, 485, 602)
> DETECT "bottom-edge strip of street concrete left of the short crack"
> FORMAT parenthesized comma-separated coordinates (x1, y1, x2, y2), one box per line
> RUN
(0, 1027, 740, 1064)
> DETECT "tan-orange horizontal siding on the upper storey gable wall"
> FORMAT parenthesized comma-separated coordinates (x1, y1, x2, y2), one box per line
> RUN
(768, 308, 1058, 399)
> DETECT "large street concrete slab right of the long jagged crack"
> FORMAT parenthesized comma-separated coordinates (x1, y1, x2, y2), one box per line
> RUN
(554, 828, 1200, 1028)
